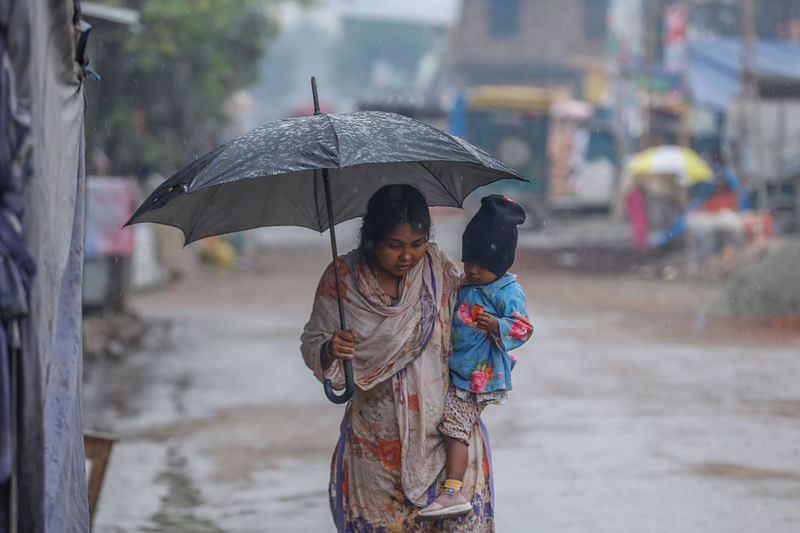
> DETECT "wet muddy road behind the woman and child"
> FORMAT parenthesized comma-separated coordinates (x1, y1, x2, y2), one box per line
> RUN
(85, 216, 800, 533)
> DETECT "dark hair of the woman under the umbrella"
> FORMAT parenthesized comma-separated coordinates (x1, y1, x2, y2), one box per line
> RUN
(358, 185, 431, 259)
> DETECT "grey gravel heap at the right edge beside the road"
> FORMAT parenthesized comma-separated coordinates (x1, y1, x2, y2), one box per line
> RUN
(719, 241, 800, 319)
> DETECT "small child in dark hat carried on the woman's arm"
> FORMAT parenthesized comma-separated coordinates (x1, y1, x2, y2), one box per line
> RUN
(419, 194, 533, 519)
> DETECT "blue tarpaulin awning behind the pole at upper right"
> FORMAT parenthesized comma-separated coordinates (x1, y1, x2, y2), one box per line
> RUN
(688, 38, 800, 112)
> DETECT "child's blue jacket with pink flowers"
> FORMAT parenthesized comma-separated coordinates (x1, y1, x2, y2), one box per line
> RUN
(450, 273, 533, 393)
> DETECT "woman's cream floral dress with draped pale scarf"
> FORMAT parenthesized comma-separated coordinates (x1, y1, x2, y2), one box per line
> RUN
(301, 243, 494, 533)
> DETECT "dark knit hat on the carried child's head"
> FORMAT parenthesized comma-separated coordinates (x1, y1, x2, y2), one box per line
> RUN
(461, 194, 525, 276)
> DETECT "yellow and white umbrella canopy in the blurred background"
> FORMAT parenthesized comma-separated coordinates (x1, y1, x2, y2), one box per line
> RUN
(626, 145, 714, 186)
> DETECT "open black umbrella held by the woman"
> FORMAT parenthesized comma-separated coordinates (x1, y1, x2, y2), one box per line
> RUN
(126, 78, 528, 403)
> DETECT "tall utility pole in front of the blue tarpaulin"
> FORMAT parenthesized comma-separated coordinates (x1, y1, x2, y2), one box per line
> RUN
(739, 0, 769, 209)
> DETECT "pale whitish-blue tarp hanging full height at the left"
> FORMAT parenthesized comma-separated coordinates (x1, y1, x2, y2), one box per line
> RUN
(27, 0, 89, 533)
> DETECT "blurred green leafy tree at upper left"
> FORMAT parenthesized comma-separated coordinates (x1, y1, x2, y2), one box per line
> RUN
(86, 0, 277, 175)
